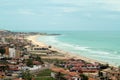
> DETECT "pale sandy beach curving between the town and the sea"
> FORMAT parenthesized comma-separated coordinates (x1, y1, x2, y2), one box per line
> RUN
(26, 35, 106, 64)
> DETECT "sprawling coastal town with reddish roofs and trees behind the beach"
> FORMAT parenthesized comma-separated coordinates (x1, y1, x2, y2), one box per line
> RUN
(0, 30, 120, 80)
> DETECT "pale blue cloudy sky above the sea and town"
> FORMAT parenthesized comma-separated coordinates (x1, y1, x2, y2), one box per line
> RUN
(0, 0, 120, 31)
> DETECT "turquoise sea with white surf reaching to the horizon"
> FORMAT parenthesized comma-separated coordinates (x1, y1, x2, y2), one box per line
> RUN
(39, 31, 120, 66)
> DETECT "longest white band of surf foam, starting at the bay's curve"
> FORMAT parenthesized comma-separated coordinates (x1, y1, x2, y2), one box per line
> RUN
(39, 36, 110, 55)
